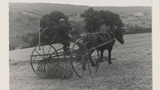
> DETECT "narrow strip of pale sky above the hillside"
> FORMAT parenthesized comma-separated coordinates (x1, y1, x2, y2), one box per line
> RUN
(9, 0, 152, 6)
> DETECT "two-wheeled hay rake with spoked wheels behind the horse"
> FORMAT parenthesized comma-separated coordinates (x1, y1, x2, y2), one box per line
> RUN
(31, 38, 99, 77)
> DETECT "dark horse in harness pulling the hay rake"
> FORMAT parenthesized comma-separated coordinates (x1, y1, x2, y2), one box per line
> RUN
(84, 30, 124, 66)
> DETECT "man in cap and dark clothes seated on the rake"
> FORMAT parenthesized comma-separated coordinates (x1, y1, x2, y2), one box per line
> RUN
(52, 19, 70, 54)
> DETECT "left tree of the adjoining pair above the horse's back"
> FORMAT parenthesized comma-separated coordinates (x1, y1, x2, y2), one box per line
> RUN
(81, 8, 101, 33)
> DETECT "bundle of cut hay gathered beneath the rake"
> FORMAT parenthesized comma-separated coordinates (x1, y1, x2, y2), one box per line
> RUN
(37, 60, 73, 79)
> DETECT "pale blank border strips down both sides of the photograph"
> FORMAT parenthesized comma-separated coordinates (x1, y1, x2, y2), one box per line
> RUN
(0, 0, 160, 90)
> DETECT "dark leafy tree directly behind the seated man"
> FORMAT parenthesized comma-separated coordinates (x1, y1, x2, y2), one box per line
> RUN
(30, 11, 71, 46)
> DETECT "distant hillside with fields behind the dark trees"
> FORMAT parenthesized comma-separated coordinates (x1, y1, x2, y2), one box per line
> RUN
(9, 3, 152, 47)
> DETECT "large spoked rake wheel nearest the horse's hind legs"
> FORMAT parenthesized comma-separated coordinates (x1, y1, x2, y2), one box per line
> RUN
(71, 39, 99, 78)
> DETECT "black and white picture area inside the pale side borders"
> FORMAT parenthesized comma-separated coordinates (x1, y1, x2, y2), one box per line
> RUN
(4, 0, 158, 90)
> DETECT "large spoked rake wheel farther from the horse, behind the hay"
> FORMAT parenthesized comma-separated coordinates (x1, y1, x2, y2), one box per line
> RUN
(30, 44, 59, 77)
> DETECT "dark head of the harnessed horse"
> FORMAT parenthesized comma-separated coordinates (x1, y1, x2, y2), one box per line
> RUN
(112, 30, 124, 44)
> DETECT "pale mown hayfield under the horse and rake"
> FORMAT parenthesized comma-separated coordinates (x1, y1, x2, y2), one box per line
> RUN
(9, 33, 152, 90)
